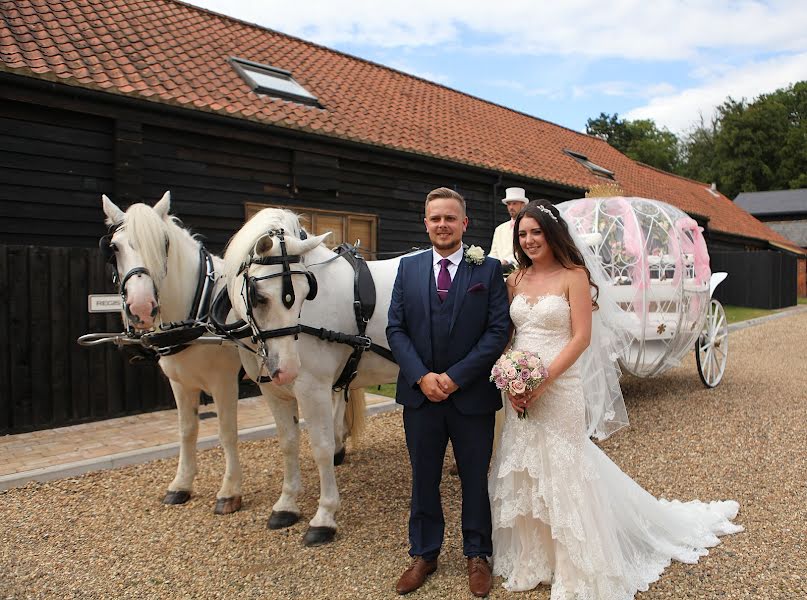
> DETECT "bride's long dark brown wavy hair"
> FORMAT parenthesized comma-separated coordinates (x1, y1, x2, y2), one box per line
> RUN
(513, 200, 600, 310)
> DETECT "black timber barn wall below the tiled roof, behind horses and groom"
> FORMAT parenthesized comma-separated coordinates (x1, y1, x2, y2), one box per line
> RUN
(0, 73, 581, 434)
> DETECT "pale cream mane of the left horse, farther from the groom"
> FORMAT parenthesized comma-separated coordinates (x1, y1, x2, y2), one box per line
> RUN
(123, 204, 199, 279)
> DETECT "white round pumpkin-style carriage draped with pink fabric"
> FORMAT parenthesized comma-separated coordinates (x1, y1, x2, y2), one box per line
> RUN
(558, 196, 728, 387)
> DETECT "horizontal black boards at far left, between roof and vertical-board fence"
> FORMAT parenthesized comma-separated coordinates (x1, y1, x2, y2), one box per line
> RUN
(0, 99, 114, 246)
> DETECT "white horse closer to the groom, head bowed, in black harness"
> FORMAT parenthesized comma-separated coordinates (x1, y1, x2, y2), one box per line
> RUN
(224, 209, 399, 546)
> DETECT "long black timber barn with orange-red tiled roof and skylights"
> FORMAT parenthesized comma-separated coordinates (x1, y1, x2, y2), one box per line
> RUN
(0, 0, 801, 433)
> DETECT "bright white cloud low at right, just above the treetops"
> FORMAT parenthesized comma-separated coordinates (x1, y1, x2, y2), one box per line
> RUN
(625, 52, 807, 132)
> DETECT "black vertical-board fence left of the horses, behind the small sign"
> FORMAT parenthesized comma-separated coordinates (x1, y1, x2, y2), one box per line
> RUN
(0, 244, 173, 435)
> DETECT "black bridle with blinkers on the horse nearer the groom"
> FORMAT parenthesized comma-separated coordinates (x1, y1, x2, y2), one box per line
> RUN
(238, 229, 318, 344)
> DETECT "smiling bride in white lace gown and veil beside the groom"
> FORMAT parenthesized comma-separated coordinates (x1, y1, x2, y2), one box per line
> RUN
(488, 200, 742, 600)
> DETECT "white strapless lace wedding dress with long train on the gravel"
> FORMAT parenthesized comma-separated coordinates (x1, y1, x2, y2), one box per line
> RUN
(488, 295, 742, 600)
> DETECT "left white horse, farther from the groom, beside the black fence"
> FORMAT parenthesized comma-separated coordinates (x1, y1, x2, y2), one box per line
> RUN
(103, 192, 241, 514)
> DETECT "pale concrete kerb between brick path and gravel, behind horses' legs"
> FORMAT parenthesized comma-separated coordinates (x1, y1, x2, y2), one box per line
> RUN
(0, 394, 399, 491)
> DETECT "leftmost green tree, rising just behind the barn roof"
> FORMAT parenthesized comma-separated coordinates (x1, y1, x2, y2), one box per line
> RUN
(586, 113, 680, 172)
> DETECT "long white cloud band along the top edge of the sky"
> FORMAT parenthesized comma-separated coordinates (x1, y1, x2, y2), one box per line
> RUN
(191, 0, 807, 60)
